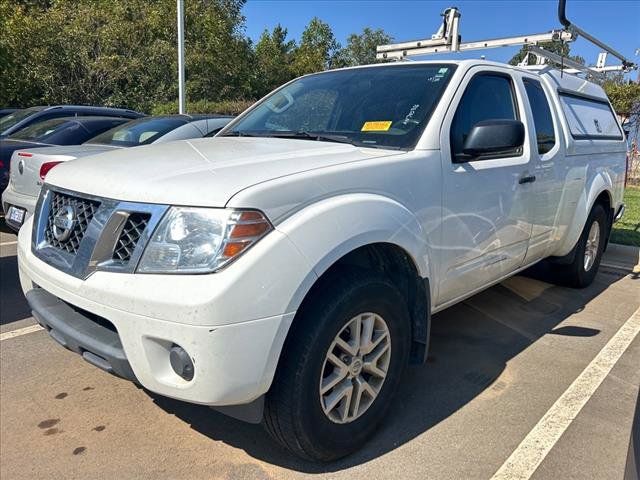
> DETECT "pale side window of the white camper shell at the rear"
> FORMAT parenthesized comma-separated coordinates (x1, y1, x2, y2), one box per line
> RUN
(560, 92, 623, 140)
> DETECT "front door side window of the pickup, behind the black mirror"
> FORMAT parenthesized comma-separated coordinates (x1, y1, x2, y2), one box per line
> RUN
(450, 73, 519, 158)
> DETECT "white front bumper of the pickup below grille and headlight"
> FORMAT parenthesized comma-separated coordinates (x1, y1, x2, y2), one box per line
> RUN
(18, 219, 306, 406)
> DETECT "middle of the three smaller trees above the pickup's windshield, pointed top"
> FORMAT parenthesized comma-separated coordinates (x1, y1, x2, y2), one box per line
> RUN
(292, 17, 340, 75)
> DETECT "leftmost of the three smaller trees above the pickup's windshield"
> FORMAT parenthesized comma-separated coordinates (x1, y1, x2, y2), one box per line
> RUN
(254, 25, 296, 97)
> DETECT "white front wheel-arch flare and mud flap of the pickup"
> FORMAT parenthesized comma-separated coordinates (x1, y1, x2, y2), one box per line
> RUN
(276, 193, 436, 364)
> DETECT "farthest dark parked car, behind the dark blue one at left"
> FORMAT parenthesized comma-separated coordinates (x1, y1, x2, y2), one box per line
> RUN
(0, 105, 144, 138)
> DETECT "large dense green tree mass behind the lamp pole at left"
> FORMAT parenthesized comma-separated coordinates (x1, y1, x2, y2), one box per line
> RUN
(0, 0, 253, 111)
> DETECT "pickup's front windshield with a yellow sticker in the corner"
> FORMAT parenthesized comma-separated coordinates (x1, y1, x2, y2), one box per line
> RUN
(223, 64, 455, 149)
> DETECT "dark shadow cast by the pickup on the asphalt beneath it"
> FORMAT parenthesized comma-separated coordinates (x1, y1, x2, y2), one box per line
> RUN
(149, 268, 625, 473)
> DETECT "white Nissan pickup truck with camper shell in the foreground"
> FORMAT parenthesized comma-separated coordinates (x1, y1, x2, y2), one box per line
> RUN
(18, 60, 626, 460)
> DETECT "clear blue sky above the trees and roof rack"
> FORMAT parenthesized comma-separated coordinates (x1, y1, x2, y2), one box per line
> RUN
(244, 0, 640, 70)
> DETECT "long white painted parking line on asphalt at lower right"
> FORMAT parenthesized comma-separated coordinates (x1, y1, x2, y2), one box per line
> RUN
(491, 309, 640, 480)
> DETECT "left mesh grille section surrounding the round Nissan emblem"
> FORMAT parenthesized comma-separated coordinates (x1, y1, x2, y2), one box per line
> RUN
(44, 192, 100, 255)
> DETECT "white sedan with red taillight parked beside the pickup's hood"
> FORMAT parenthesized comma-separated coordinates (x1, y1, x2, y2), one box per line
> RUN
(2, 115, 233, 230)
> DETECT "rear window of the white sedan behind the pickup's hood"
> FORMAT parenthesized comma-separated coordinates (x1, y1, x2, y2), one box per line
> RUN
(85, 117, 188, 147)
